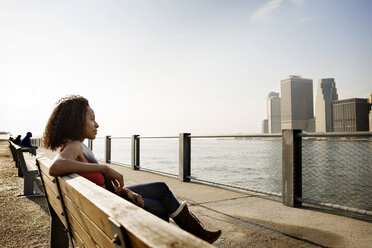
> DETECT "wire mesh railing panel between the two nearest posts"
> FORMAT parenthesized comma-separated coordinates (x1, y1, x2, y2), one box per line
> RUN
(190, 134, 282, 197)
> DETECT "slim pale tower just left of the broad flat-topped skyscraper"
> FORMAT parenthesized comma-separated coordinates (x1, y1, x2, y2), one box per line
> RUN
(266, 92, 282, 133)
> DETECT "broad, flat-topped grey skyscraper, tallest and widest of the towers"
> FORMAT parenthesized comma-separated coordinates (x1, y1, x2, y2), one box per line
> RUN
(280, 76, 314, 132)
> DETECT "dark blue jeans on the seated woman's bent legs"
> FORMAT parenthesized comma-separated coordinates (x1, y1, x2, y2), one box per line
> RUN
(123, 182, 180, 221)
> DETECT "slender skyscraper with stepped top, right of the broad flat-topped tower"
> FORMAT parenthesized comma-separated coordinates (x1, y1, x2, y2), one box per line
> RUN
(315, 78, 338, 133)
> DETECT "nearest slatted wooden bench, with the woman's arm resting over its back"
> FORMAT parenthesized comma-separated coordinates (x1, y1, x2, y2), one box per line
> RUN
(37, 158, 213, 248)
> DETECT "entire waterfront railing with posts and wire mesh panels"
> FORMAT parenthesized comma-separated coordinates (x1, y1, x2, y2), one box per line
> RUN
(32, 130, 372, 216)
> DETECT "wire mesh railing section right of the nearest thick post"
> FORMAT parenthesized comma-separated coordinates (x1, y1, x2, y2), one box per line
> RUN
(299, 132, 372, 215)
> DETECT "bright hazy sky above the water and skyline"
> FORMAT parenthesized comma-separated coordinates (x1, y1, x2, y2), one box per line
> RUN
(0, 0, 372, 136)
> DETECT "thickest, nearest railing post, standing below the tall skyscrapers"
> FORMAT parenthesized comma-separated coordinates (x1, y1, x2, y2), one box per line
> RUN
(282, 129, 302, 207)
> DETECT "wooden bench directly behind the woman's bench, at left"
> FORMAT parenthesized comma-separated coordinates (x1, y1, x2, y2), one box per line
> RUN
(9, 141, 44, 197)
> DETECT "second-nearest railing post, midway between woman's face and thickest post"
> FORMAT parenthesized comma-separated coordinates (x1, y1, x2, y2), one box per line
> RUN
(179, 133, 191, 182)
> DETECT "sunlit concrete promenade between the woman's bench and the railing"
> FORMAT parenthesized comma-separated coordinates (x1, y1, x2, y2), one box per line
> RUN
(38, 149, 372, 248)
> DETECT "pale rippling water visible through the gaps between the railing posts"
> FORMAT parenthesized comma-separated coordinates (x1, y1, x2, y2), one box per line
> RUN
(93, 138, 372, 210)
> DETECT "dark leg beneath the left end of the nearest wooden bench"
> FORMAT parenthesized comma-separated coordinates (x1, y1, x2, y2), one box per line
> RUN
(49, 211, 69, 248)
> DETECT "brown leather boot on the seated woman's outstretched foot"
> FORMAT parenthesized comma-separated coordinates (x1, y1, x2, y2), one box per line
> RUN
(171, 204, 222, 244)
